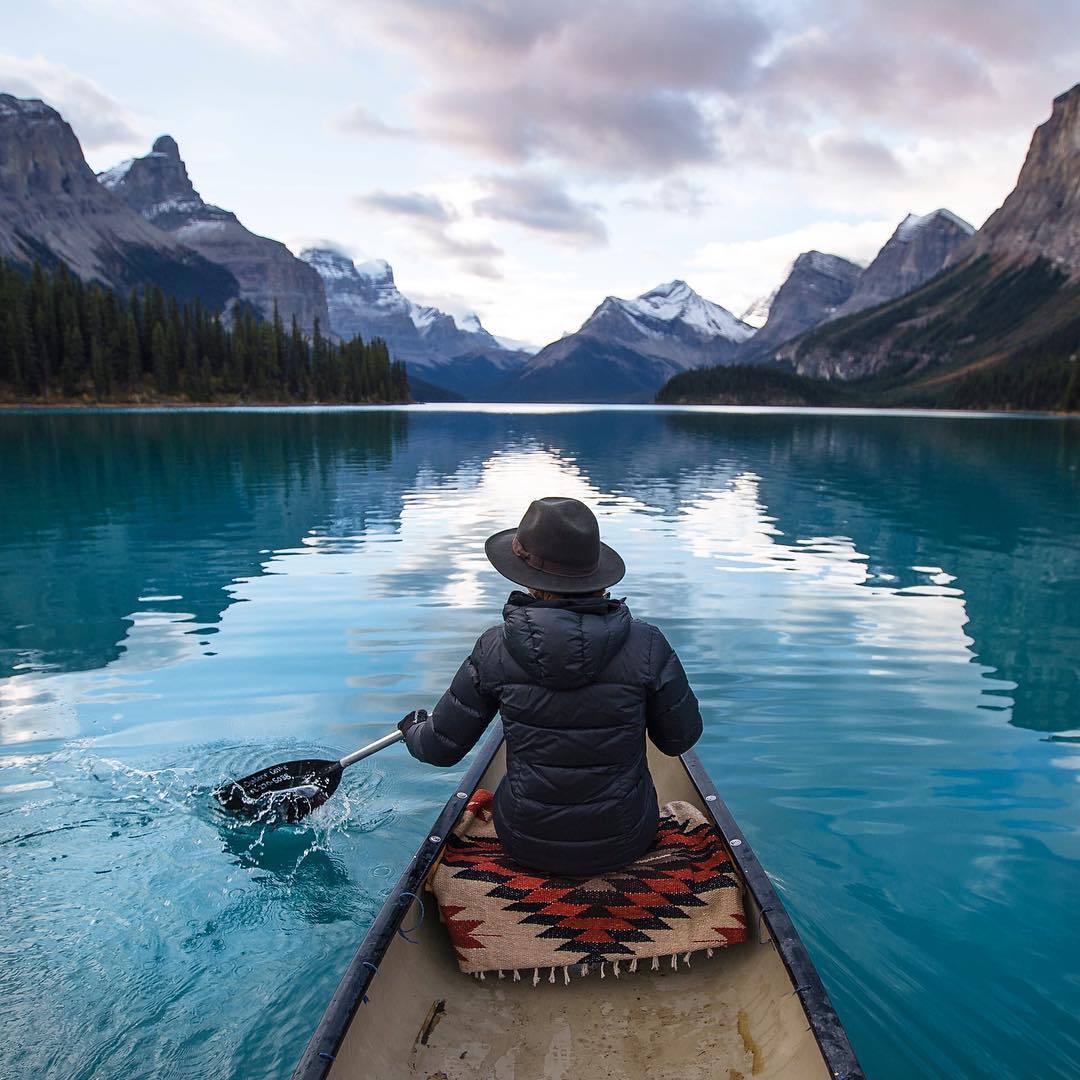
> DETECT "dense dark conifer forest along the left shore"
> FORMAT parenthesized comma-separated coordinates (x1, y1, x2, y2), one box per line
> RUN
(0, 261, 409, 403)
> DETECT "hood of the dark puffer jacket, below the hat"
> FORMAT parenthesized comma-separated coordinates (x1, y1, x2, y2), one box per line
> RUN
(502, 591, 631, 690)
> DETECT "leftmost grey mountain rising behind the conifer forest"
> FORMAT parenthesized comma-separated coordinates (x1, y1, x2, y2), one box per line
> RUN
(0, 94, 239, 309)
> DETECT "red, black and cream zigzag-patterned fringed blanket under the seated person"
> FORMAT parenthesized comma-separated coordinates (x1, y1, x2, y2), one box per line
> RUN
(431, 788, 746, 983)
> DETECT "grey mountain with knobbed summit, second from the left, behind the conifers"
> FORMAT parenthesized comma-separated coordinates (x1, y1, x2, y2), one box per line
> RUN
(98, 135, 329, 333)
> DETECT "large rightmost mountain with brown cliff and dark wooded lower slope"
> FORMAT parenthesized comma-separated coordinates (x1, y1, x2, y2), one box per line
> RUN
(779, 84, 1080, 408)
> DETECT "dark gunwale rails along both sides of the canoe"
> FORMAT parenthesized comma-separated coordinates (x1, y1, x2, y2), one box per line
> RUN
(292, 721, 865, 1080)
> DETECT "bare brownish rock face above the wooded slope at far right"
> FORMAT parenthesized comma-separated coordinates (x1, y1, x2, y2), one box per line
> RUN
(959, 83, 1080, 275)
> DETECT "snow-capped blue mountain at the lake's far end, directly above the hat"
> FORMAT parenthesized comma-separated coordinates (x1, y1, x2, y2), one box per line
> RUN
(500, 281, 754, 402)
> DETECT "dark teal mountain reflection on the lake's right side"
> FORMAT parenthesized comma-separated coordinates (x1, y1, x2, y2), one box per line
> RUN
(666, 414, 1080, 731)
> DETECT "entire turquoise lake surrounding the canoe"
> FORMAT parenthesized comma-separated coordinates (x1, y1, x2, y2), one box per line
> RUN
(0, 407, 1080, 1080)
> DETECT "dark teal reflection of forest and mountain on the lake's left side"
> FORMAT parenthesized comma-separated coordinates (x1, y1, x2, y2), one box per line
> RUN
(0, 413, 405, 675)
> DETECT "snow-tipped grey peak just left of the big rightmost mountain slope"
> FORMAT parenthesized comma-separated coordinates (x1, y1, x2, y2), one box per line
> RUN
(829, 210, 975, 319)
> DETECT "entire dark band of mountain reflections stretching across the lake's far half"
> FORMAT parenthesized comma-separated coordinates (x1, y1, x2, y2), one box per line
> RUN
(0, 409, 1080, 730)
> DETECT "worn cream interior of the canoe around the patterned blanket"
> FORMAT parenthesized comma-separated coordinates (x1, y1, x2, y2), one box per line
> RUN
(329, 745, 829, 1080)
